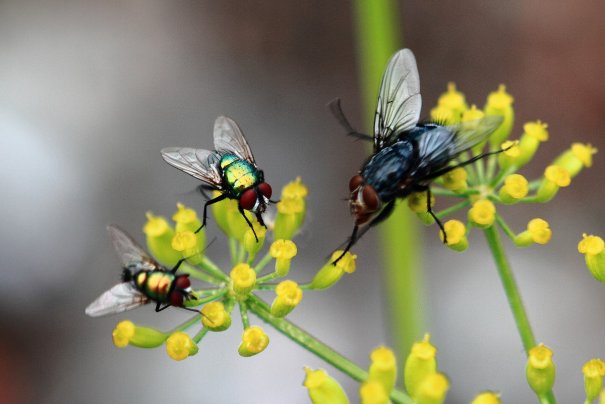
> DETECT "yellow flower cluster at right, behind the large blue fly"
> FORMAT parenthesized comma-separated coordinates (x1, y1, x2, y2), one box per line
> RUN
(408, 83, 597, 251)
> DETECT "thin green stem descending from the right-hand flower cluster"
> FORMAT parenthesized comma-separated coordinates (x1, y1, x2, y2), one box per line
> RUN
(483, 226, 556, 404)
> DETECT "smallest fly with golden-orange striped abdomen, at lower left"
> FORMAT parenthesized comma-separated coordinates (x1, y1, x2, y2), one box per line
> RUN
(86, 225, 198, 317)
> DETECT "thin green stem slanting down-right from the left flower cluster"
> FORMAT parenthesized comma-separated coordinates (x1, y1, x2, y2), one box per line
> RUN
(247, 295, 414, 404)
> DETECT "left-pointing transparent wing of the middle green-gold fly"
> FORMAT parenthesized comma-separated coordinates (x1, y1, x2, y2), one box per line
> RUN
(162, 147, 222, 190)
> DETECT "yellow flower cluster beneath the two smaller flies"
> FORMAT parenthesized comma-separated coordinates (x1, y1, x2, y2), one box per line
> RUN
(112, 178, 355, 361)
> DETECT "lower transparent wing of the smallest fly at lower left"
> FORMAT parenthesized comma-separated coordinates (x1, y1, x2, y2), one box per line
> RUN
(85, 282, 149, 317)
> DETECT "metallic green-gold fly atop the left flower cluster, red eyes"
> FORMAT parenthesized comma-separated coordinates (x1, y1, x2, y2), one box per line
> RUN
(162, 116, 275, 241)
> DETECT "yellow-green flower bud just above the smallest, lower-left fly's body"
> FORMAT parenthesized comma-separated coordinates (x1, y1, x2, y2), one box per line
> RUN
(143, 212, 182, 268)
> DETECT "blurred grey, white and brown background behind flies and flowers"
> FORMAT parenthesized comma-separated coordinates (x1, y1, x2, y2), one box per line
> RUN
(0, 0, 605, 404)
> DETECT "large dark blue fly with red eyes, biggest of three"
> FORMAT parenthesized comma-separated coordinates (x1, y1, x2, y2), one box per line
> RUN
(329, 49, 502, 263)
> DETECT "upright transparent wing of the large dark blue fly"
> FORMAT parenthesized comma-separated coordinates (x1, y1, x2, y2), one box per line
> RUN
(374, 49, 422, 151)
